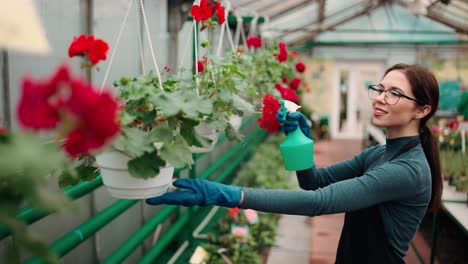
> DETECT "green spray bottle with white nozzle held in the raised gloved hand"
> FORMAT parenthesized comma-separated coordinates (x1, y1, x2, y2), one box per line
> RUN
(278, 100, 315, 171)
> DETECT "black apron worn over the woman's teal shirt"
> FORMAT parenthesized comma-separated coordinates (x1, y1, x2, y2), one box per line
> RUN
(335, 139, 419, 264)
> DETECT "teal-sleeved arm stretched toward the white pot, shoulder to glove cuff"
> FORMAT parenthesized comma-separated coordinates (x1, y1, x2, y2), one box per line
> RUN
(239, 158, 430, 216)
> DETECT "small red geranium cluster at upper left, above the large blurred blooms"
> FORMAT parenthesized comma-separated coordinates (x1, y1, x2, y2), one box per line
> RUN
(68, 34, 109, 65)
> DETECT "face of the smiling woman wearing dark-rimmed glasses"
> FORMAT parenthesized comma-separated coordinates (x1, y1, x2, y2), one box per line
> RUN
(372, 70, 420, 138)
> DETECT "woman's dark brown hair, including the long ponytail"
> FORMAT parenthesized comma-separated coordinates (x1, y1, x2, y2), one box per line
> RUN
(384, 63, 442, 211)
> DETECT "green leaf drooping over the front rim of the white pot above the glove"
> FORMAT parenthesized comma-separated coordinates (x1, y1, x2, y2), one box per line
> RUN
(127, 151, 166, 179)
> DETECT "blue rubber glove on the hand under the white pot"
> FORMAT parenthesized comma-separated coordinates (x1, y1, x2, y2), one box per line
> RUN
(146, 179, 242, 208)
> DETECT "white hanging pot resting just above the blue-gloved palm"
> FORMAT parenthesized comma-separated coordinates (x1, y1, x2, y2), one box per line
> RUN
(96, 151, 174, 199)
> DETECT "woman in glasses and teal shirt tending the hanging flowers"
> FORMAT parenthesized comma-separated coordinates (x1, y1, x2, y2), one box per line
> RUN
(147, 64, 442, 263)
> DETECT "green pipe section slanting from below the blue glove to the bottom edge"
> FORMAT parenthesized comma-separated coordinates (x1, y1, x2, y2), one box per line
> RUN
(103, 206, 177, 264)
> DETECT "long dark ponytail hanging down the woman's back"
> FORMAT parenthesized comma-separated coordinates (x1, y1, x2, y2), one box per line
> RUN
(419, 124, 443, 212)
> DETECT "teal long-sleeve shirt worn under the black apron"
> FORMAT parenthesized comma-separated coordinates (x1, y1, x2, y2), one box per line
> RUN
(241, 136, 432, 258)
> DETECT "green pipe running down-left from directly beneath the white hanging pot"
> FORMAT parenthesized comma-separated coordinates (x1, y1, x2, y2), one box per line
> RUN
(26, 199, 139, 263)
